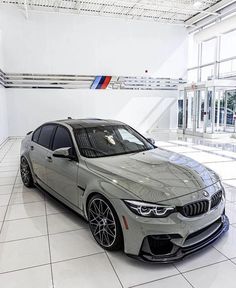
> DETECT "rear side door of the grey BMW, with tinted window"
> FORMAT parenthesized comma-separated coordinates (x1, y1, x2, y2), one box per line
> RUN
(30, 124, 57, 184)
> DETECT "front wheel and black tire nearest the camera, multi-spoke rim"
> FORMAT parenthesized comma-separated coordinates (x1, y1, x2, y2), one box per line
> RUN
(87, 194, 123, 251)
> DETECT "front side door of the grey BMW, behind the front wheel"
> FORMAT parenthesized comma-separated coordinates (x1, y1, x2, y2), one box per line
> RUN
(46, 125, 78, 206)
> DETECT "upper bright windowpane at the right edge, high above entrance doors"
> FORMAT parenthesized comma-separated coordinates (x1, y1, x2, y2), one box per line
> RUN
(220, 30, 236, 59)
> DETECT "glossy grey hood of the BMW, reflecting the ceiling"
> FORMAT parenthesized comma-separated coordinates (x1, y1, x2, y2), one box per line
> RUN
(86, 148, 219, 203)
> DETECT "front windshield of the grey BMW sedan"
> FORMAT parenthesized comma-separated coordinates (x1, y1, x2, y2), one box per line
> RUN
(75, 125, 155, 158)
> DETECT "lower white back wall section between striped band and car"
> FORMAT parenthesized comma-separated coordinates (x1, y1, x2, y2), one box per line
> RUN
(6, 89, 177, 136)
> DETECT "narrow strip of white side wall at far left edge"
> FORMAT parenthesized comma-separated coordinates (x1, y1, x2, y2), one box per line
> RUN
(0, 30, 8, 144)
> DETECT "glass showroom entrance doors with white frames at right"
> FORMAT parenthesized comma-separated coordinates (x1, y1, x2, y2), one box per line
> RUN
(178, 80, 236, 137)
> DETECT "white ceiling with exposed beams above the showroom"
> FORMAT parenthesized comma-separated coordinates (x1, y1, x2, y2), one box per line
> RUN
(0, 0, 232, 25)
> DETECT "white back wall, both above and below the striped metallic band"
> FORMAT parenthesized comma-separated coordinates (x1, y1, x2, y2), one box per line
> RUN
(0, 6, 187, 136)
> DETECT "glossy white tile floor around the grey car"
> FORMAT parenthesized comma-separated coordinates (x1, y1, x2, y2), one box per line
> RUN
(0, 137, 236, 288)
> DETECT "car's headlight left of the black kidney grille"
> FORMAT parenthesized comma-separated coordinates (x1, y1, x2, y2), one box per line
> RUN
(124, 200, 175, 218)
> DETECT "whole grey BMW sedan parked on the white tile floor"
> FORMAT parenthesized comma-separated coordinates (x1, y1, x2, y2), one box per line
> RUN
(20, 119, 228, 262)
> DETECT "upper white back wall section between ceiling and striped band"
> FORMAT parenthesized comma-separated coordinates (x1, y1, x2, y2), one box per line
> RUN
(0, 6, 187, 78)
